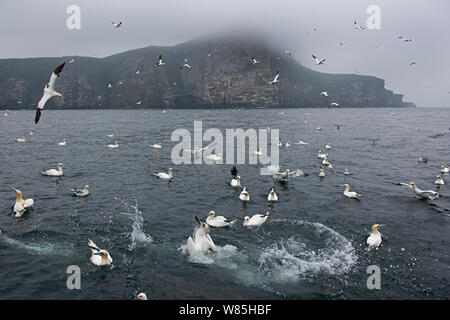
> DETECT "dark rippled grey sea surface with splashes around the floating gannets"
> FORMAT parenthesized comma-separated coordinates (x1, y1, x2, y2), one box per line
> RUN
(0, 108, 450, 299)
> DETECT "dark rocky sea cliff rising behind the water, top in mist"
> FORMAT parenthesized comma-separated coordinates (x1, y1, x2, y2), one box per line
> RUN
(0, 39, 411, 108)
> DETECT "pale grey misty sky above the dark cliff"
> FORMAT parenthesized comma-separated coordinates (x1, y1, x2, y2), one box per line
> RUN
(0, 0, 450, 107)
